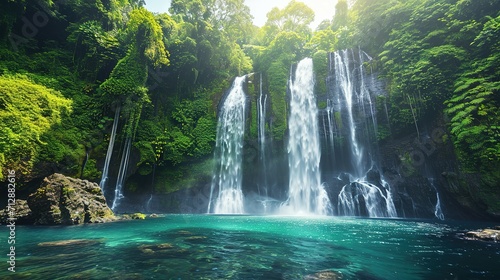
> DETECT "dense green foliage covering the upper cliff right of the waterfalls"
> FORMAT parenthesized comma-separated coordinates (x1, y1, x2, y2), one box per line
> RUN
(350, 0, 500, 209)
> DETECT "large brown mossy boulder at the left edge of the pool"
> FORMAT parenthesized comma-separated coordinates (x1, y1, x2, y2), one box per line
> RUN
(28, 173, 116, 225)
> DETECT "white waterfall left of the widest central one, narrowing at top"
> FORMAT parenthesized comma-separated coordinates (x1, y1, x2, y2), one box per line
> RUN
(208, 76, 246, 214)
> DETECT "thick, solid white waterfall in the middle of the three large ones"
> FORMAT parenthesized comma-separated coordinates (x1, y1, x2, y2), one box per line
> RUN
(282, 58, 331, 215)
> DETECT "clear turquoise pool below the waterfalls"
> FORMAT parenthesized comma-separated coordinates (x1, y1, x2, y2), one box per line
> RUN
(0, 215, 500, 279)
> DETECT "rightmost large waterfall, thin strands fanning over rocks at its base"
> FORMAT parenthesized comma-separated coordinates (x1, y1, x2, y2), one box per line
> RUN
(329, 50, 397, 217)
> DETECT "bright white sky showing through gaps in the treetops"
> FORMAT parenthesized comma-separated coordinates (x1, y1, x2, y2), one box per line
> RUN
(145, 0, 337, 29)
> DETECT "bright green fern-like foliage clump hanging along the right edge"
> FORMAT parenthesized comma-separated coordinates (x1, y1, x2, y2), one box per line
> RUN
(446, 17, 500, 172)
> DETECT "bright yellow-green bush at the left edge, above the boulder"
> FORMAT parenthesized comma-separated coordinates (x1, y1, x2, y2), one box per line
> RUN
(0, 75, 71, 176)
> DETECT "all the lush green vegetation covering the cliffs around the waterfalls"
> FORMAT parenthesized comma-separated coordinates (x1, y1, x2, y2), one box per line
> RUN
(0, 0, 500, 209)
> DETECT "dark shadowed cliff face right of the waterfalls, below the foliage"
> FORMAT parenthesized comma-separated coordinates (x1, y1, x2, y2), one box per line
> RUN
(380, 118, 495, 219)
